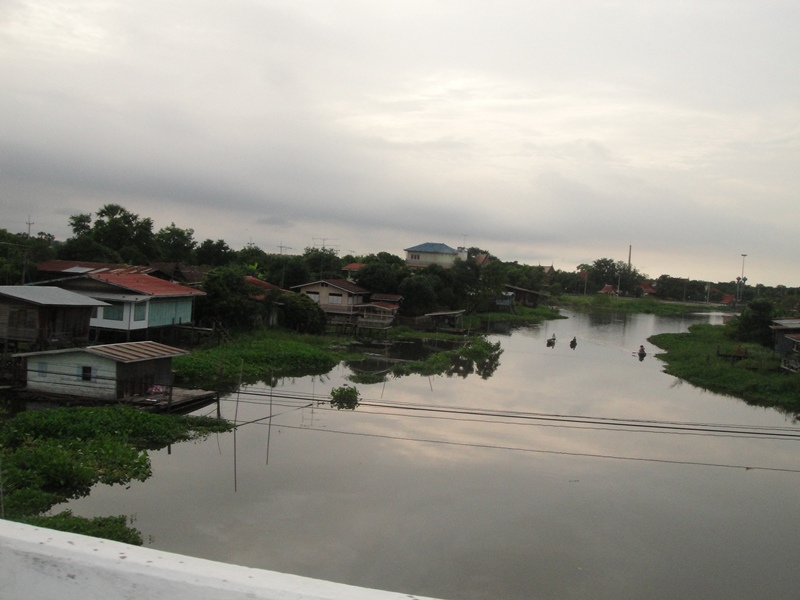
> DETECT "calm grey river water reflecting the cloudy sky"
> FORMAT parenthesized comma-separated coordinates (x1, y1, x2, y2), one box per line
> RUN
(58, 314, 800, 600)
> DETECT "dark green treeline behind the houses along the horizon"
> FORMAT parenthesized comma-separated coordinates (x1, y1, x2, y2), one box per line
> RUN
(0, 204, 800, 332)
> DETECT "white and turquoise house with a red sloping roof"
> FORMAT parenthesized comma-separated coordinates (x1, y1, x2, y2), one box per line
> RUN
(34, 273, 205, 341)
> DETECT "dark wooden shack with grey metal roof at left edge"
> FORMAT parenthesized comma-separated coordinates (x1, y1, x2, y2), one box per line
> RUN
(0, 285, 109, 354)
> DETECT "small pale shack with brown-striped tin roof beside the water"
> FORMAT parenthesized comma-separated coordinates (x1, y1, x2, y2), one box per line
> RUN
(14, 342, 188, 402)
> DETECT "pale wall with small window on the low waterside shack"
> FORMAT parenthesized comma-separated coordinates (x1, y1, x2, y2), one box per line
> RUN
(26, 350, 117, 400)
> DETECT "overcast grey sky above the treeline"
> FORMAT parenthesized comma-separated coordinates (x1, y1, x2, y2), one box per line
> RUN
(0, 0, 800, 286)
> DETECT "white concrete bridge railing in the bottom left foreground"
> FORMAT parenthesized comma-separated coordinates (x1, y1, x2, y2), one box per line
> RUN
(0, 520, 444, 600)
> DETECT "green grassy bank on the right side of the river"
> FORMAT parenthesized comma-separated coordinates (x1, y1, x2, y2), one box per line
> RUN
(649, 324, 800, 413)
